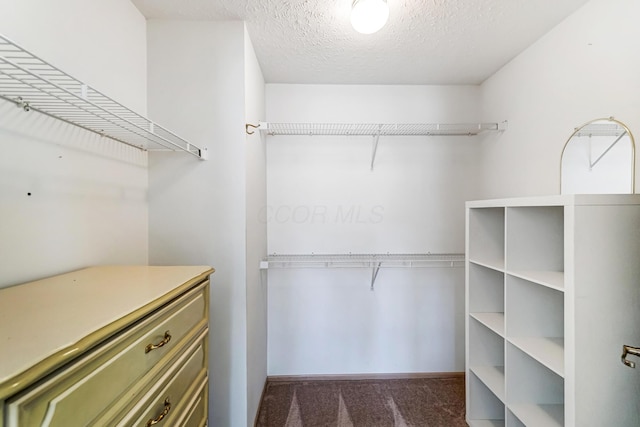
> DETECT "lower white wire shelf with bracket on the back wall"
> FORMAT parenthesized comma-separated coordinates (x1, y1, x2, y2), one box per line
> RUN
(260, 253, 465, 290)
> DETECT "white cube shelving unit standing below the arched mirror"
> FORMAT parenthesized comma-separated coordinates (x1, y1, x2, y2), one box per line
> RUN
(466, 195, 640, 427)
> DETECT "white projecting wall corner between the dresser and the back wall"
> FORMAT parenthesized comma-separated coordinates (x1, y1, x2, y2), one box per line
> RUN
(147, 21, 266, 426)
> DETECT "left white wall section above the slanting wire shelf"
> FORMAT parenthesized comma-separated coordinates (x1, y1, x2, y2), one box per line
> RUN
(0, 0, 147, 115)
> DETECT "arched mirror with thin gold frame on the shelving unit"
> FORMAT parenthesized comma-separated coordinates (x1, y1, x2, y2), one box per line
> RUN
(560, 117, 636, 194)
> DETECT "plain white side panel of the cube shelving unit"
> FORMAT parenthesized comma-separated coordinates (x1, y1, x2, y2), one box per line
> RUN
(573, 206, 640, 427)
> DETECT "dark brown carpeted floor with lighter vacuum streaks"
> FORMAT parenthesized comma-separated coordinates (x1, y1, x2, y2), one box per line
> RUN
(256, 375, 467, 427)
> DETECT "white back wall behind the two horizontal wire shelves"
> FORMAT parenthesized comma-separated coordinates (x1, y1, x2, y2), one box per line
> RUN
(263, 84, 480, 375)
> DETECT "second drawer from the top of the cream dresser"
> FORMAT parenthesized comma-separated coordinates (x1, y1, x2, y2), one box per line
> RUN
(114, 335, 207, 427)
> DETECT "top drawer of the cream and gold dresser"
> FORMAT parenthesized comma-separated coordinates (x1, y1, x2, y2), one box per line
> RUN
(5, 281, 209, 427)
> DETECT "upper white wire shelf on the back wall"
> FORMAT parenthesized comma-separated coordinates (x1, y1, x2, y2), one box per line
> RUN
(258, 122, 506, 136)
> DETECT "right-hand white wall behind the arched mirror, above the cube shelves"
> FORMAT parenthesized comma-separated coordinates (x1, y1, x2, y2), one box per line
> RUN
(482, 0, 640, 197)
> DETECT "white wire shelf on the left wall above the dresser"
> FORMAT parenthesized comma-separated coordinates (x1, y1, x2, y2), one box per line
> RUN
(0, 35, 207, 159)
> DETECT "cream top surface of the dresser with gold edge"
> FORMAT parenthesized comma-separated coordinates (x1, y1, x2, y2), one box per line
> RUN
(0, 266, 213, 400)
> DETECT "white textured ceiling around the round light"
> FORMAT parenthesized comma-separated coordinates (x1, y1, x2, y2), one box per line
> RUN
(132, 0, 587, 84)
